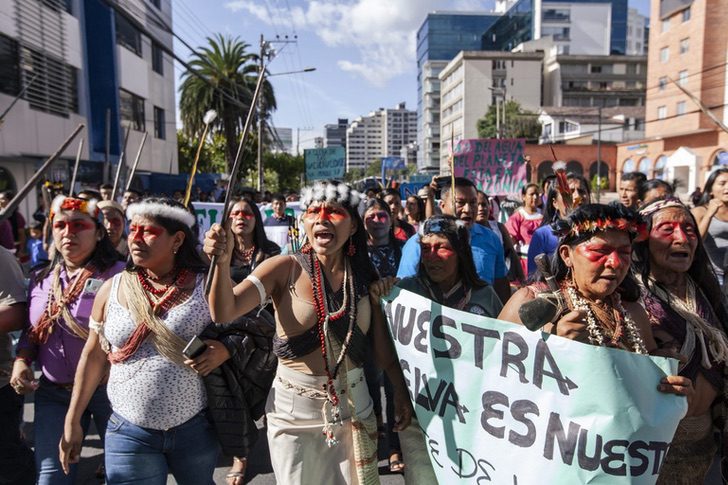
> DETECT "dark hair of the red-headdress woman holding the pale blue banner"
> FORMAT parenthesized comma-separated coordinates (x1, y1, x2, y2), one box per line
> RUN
(534, 203, 641, 301)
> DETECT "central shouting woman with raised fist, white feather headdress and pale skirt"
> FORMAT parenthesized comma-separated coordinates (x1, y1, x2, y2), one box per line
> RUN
(204, 182, 411, 484)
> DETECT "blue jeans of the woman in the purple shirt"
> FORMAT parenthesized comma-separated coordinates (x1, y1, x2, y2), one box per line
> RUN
(33, 378, 111, 485)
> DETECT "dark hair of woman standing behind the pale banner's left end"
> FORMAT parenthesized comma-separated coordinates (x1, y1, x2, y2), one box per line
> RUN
(417, 214, 488, 288)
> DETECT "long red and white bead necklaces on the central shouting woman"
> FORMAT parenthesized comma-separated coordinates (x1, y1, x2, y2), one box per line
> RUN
(309, 251, 356, 447)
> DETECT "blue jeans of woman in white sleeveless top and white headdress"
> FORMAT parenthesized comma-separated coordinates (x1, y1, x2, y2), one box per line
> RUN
(106, 411, 219, 485)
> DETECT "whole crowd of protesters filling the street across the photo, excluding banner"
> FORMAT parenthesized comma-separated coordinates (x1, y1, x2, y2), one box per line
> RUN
(0, 164, 728, 485)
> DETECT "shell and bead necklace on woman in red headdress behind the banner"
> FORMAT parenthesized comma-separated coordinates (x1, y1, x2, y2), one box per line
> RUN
(566, 285, 647, 354)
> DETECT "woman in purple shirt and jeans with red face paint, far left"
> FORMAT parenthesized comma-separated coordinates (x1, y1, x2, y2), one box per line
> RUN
(10, 196, 124, 485)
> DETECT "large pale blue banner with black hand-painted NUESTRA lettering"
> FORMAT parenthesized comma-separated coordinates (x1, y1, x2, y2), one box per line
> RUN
(383, 288, 687, 485)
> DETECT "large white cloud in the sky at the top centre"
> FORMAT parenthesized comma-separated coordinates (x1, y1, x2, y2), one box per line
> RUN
(225, 0, 450, 87)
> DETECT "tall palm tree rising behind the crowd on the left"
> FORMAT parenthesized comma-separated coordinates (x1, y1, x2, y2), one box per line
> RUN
(180, 34, 276, 172)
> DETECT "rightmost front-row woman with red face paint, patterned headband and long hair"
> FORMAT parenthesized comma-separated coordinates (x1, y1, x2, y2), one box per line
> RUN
(634, 198, 728, 484)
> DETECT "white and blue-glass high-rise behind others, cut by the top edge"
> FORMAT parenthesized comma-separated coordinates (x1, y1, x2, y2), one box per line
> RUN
(482, 0, 627, 55)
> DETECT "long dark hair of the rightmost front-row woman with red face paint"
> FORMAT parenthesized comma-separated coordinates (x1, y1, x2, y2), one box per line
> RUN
(632, 197, 728, 330)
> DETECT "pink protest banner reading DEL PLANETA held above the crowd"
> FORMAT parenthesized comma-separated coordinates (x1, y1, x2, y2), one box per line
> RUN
(454, 138, 526, 196)
